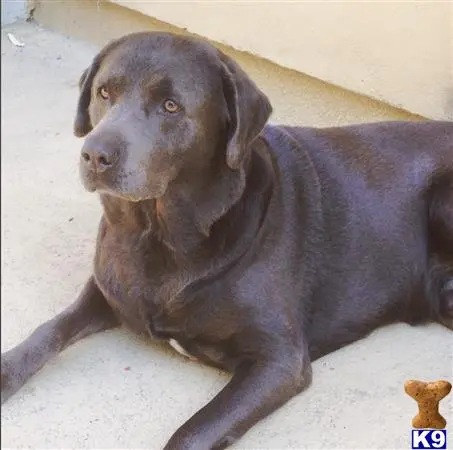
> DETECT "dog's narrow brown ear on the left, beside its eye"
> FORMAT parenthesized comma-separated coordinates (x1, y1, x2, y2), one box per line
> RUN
(74, 59, 100, 137)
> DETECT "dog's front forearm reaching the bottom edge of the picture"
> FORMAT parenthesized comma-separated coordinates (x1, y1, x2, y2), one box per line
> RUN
(165, 354, 311, 450)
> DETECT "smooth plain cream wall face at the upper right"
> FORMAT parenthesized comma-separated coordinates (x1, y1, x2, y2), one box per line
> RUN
(112, 0, 453, 119)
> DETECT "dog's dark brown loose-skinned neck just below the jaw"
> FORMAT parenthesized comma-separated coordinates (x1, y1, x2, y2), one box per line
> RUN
(101, 141, 272, 256)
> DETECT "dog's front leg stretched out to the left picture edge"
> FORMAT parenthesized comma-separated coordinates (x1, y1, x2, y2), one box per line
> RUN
(1, 277, 119, 403)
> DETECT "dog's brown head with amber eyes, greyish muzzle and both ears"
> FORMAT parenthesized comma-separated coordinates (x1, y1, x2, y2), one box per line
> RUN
(74, 33, 271, 201)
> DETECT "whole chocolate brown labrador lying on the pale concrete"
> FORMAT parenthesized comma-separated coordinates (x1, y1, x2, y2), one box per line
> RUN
(1, 33, 453, 450)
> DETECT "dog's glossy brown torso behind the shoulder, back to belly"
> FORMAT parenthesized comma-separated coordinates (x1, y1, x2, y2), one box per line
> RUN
(267, 122, 453, 358)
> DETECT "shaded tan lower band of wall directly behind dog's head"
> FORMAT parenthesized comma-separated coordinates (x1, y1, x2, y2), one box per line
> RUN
(34, 0, 420, 126)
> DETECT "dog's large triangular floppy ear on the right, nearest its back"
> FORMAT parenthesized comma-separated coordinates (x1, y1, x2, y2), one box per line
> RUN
(219, 52, 272, 169)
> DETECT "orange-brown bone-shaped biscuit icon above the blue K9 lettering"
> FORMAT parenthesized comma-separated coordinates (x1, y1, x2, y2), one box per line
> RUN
(404, 380, 451, 430)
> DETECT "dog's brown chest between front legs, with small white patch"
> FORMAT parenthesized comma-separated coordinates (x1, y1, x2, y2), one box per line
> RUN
(94, 228, 247, 370)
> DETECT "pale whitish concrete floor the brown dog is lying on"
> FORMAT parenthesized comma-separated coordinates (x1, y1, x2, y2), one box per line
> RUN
(1, 24, 453, 449)
